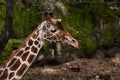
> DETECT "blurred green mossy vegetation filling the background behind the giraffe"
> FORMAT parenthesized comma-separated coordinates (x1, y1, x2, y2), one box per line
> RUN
(0, 0, 120, 63)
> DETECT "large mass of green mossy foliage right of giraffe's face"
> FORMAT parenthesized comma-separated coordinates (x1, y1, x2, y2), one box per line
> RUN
(58, 1, 118, 53)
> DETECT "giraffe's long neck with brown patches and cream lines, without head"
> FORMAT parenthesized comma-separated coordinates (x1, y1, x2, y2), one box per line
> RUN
(0, 23, 44, 80)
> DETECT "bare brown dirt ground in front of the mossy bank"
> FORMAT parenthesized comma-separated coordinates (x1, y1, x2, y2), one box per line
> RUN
(22, 58, 120, 80)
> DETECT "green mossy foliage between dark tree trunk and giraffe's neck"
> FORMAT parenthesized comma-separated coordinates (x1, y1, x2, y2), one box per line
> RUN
(13, 3, 42, 38)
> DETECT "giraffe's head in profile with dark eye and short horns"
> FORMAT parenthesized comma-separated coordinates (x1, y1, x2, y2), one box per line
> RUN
(40, 11, 78, 48)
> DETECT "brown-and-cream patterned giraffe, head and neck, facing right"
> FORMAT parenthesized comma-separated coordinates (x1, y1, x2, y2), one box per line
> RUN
(0, 13, 78, 80)
